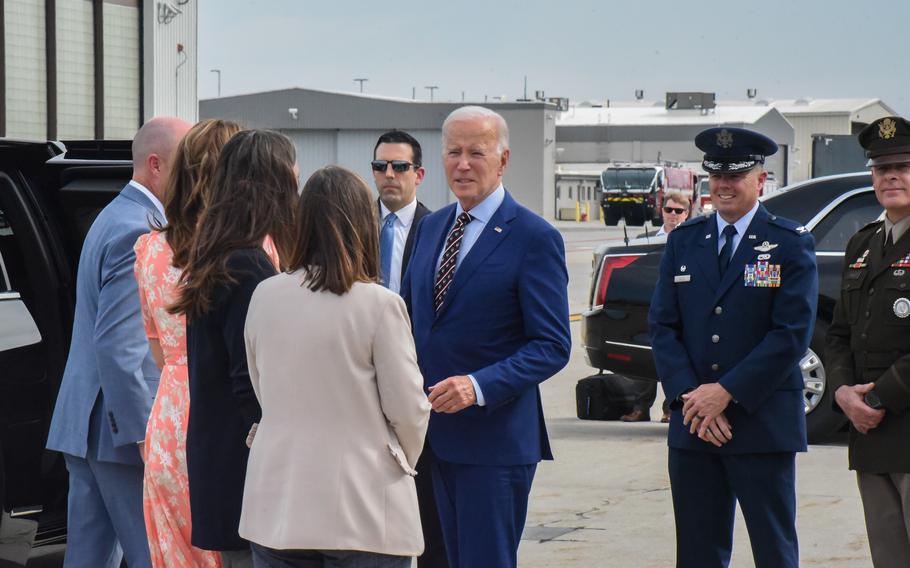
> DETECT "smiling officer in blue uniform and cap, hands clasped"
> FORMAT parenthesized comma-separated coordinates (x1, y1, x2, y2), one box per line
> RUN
(648, 128, 818, 568)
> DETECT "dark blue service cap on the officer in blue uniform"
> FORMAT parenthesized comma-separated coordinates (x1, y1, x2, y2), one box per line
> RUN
(695, 127, 777, 174)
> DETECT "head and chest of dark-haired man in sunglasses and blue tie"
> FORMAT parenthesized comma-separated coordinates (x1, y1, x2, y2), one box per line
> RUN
(370, 130, 431, 292)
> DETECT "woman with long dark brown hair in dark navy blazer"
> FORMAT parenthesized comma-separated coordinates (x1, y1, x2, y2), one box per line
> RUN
(172, 130, 297, 566)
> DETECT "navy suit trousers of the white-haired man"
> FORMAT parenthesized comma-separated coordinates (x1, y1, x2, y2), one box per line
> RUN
(432, 458, 537, 568)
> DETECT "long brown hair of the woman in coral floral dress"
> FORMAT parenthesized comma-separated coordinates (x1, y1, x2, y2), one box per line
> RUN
(155, 119, 242, 268)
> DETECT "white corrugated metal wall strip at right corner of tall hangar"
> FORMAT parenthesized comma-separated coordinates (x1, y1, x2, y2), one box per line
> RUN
(144, 0, 199, 122)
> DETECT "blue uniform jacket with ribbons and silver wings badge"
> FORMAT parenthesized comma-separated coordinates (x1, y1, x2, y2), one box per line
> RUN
(648, 205, 818, 454)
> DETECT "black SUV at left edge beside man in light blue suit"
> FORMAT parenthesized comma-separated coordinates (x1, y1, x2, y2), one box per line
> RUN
(0, 139, 132, 566)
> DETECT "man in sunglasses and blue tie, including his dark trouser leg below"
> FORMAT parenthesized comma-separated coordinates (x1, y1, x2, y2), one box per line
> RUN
(370, 130, 448, 568)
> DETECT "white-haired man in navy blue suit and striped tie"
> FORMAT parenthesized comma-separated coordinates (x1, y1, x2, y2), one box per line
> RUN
(402, 107, 571, 568)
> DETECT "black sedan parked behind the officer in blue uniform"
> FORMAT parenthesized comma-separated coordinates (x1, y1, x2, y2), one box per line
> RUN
(581, 172, 882, 442)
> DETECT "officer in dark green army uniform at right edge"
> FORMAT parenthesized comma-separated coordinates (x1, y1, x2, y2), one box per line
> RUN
(825, 116, 910, 568)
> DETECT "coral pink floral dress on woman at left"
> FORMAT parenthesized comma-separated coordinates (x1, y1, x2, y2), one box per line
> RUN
(135, 231, 221, 568)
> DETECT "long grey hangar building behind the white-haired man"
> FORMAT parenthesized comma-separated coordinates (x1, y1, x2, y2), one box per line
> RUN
(199, 88, 557, 219)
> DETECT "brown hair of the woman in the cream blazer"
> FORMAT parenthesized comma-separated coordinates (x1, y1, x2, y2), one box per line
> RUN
(287, 166, 379, 295)
